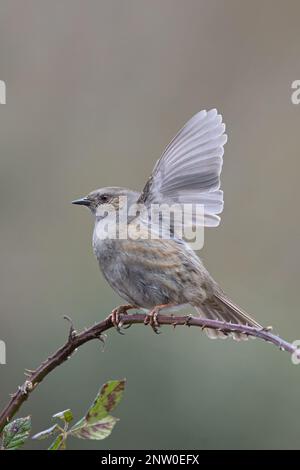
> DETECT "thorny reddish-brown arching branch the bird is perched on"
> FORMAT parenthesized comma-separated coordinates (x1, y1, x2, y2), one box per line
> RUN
(0, 313, 300, 433)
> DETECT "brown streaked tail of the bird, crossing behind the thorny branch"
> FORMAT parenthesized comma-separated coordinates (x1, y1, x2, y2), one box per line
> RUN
(196, 294, 262, 341)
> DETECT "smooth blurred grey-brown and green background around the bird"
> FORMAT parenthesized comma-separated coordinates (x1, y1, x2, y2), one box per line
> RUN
(0, 0, 300, 449)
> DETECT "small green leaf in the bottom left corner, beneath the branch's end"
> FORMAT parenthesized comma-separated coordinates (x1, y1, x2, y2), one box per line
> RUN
(2, 416, 31, 450)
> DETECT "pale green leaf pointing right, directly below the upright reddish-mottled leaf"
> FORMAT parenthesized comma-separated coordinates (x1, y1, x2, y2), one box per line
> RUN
(69, 415, 118, 440)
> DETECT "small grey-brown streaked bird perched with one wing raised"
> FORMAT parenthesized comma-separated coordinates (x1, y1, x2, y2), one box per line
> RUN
(72, 109, 263, 340)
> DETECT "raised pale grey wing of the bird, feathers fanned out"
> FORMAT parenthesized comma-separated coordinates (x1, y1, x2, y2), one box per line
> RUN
(138, 109, 227, 227)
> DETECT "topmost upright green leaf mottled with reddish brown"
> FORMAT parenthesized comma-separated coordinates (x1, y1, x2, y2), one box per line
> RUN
(85, 379, 125, 423)
